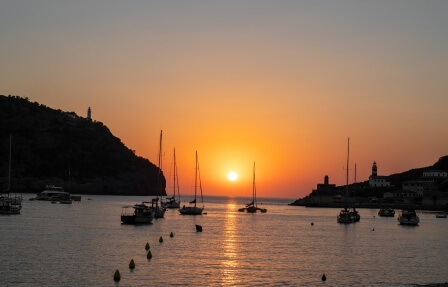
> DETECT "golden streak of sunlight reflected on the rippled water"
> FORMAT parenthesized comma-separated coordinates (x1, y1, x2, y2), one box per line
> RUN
(221, 203, 240, 286)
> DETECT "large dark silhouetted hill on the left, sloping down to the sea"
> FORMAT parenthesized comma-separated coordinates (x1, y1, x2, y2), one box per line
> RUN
(0, 95, 166, 195)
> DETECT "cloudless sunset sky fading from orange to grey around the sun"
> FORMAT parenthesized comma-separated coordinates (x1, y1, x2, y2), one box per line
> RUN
(0, 0, 448, 198)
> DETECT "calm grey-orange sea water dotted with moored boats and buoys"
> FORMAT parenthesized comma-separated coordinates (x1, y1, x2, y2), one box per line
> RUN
(0, 195, 448, 286)
